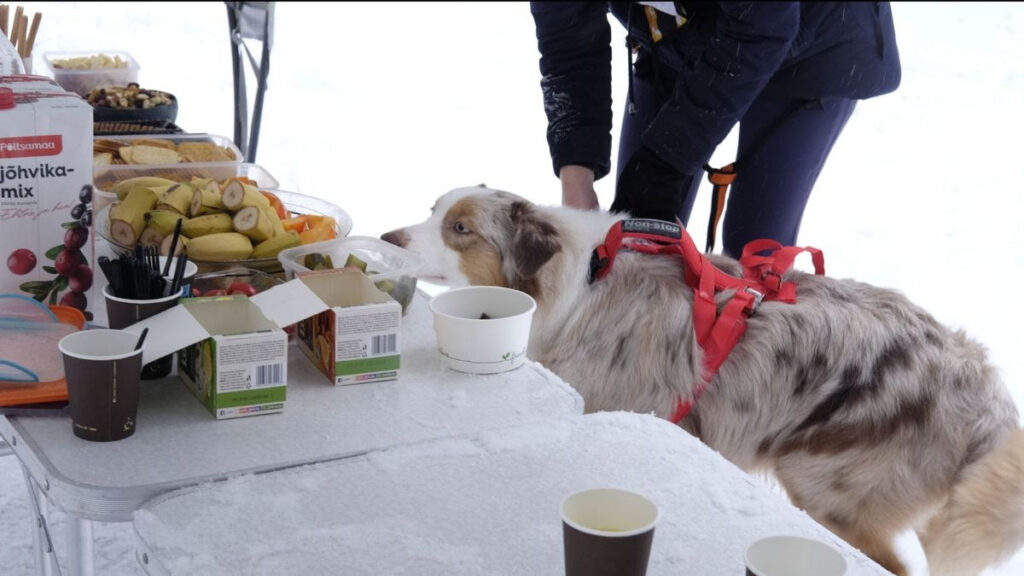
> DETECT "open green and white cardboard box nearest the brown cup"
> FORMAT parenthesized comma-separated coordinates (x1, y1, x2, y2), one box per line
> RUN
(178, 296, 288, 419)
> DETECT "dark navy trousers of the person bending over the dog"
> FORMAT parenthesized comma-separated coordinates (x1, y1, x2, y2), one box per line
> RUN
(615, 50, 857, 257)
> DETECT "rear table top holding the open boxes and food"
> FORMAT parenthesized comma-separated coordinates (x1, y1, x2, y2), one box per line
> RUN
(0, 292, 583, 522)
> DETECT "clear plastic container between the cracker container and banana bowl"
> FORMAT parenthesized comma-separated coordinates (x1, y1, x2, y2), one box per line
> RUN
(92, 159, 281, 212)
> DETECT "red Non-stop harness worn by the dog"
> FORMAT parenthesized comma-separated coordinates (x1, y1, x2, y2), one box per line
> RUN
(589, 218, 824, 423)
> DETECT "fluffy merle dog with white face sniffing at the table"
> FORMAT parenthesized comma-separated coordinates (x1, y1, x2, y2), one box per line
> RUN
(381, 184, 1024, 576)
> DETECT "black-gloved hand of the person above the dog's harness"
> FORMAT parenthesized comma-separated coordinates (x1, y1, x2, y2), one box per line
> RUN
(610, 147, 693, 222)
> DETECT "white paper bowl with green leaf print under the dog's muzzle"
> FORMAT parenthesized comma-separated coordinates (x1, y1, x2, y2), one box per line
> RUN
(430, 286, 537, 374)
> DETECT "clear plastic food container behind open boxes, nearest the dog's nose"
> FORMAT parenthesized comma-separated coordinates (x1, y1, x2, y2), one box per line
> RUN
(278, 236, 423, 314)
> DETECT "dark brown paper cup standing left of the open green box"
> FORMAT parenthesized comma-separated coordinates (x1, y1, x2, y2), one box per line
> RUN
(57, 330, 142, 442)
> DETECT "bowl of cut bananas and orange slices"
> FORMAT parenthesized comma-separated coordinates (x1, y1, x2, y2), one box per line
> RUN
(95, 177, 352, 278)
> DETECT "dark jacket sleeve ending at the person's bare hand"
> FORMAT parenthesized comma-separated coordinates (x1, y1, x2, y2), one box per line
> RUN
(530, 2, 611, 178)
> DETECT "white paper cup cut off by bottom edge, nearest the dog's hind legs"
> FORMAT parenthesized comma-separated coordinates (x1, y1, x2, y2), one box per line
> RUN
(743, 536, 846, 576)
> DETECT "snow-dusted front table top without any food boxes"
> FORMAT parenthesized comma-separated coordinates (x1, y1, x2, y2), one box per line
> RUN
(133, 412, 888, 576)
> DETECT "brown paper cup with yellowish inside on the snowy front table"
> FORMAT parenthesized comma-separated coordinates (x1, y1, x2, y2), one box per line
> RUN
(562, 488, 658, 576)
